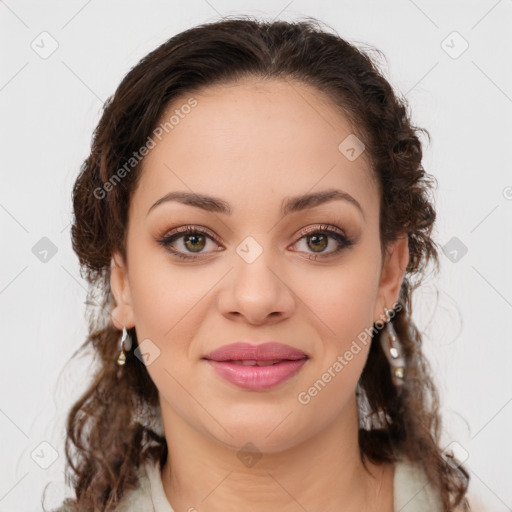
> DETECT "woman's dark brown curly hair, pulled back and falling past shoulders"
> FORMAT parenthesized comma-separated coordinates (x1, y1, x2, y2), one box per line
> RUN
(50, 16, 469, 511)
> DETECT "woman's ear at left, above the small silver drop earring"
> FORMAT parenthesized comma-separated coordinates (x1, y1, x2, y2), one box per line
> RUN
(110, 252, 135, 330)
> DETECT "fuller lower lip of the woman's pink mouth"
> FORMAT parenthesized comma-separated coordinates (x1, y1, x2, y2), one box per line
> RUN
(207, 358, 307, 391)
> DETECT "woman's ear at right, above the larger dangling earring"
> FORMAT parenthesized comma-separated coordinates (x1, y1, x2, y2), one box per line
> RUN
(373, 233, 409, 322)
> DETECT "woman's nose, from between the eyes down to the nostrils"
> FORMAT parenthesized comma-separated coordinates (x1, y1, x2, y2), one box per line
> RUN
(218, 243, 296, 325)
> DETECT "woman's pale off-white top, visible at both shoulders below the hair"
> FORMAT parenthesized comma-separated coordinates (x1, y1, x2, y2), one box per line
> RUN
(107, 460, 442, 512)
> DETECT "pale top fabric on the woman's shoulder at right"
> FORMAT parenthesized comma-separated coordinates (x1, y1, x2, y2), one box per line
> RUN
(393, 459, 443, 512)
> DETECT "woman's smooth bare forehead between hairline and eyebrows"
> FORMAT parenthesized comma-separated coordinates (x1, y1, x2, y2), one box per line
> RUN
(130, 79, 377, 218)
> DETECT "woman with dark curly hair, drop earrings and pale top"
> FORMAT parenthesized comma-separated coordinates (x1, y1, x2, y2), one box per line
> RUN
(49, 17, 469, 512)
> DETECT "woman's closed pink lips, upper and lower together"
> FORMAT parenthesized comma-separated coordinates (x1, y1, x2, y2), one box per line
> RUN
(204, 342, 308, 391)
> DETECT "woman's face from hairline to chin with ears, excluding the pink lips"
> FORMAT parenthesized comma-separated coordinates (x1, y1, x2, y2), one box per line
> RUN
(111, 76, 408, 452)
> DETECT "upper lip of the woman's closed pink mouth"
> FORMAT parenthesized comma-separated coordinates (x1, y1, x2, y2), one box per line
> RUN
(203, 341, 308, 361)
